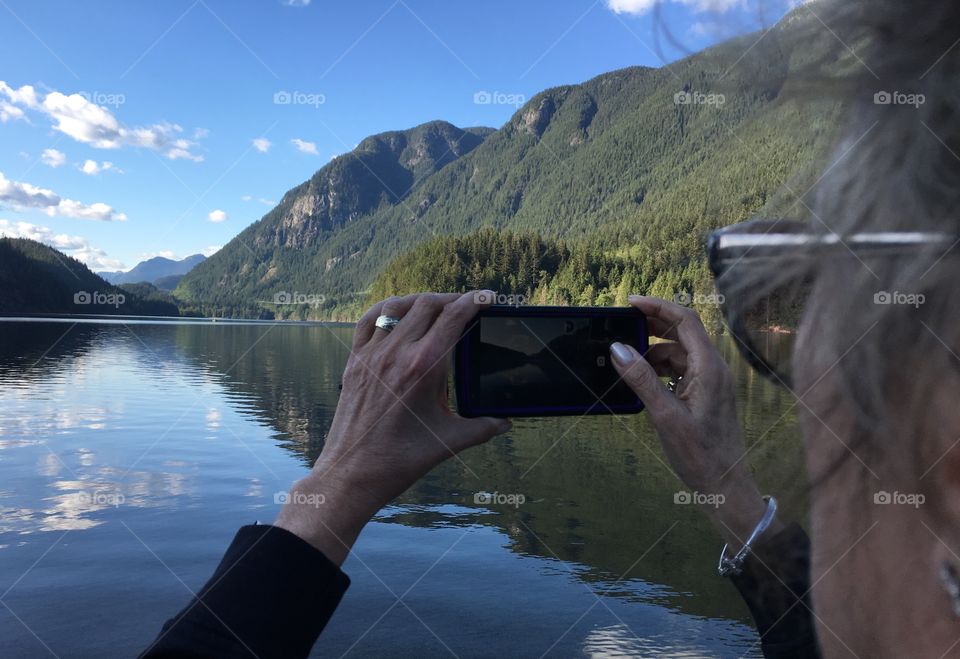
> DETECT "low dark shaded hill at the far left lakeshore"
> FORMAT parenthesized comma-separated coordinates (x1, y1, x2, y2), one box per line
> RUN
(0, 238, 179, 316)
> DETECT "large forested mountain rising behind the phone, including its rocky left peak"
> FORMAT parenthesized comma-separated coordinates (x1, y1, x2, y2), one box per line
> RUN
(175, 7, 849, 317)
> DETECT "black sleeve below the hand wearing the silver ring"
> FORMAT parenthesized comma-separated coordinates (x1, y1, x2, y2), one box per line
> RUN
(141, 525, 350, 659)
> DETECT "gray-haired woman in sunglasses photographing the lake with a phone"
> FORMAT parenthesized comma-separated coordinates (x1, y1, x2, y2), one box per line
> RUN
(146, 0, 960, 657)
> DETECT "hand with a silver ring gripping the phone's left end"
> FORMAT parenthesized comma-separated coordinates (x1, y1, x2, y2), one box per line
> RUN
(276, 292, 510, 564)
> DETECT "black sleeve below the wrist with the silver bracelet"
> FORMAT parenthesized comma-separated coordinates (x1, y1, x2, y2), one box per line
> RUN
(732, 523, 820, 659)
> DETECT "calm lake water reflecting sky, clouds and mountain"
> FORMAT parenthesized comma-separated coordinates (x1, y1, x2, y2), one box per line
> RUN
(0, 321, 803, 657)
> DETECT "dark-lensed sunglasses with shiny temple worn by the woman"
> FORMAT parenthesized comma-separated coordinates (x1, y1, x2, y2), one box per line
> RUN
(707, 219, 960, 388)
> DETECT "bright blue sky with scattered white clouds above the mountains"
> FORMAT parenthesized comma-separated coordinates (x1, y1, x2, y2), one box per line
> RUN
(0, 0, 793, 270)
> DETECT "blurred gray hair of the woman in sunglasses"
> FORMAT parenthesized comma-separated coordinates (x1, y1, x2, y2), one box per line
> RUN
(724, 0, 960, 488)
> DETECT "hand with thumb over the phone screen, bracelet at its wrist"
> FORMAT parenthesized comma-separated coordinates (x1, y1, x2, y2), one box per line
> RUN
(610, 295, 779, 548)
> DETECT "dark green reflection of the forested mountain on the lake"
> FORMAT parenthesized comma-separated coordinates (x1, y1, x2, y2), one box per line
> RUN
(163, 327, 804, 619)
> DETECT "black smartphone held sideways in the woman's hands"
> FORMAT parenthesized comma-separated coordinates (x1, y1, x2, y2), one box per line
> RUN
(454, 306, 649, 417)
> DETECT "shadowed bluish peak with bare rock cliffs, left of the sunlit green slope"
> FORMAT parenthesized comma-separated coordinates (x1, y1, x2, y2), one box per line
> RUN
(175, 121, 493, 317)
